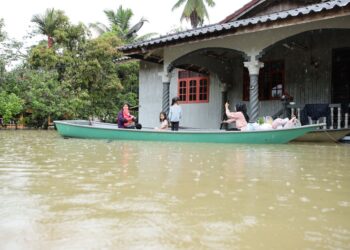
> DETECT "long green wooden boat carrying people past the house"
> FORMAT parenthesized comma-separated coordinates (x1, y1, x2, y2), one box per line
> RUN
(54, 120, 322, 144)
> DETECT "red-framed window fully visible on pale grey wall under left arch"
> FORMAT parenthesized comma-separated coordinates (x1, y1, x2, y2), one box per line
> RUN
(178, 70, 209, 103)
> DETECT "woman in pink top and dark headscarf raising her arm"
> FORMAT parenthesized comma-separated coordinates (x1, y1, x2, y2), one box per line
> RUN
(223, 102, 249, 130)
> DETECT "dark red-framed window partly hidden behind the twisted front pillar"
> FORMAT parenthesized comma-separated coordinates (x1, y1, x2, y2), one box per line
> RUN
(243, 61, 284, 101)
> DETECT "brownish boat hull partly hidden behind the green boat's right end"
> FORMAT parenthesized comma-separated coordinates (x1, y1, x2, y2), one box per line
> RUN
(293, 129, 350, 142)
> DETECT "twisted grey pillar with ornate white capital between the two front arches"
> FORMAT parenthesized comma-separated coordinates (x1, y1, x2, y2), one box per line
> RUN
(244, 59, 264, 122)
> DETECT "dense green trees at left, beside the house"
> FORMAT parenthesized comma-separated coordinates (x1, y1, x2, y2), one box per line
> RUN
(0, 9, 139, 127)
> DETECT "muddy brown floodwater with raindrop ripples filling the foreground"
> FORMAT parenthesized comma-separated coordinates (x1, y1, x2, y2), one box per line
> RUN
(0, 131, 350, 249)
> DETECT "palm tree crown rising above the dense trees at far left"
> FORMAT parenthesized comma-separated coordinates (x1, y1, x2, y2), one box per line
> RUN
(31, 8, 68, 48)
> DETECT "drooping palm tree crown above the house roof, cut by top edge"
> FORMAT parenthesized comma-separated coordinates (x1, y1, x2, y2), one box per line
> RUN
(172, 0, 215, 28)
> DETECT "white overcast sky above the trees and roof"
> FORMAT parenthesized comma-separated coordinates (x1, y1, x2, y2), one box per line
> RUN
(0, 0, 250, 39)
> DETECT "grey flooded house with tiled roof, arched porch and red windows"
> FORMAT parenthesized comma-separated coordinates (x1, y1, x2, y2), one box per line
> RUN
(119, 0, 350, 128)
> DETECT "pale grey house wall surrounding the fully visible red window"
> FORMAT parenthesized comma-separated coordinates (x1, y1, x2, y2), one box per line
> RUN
(139, 62, 222, 128)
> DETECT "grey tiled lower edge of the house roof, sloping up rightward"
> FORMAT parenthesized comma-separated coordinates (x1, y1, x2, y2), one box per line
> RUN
(118, 0, 350, 54)
